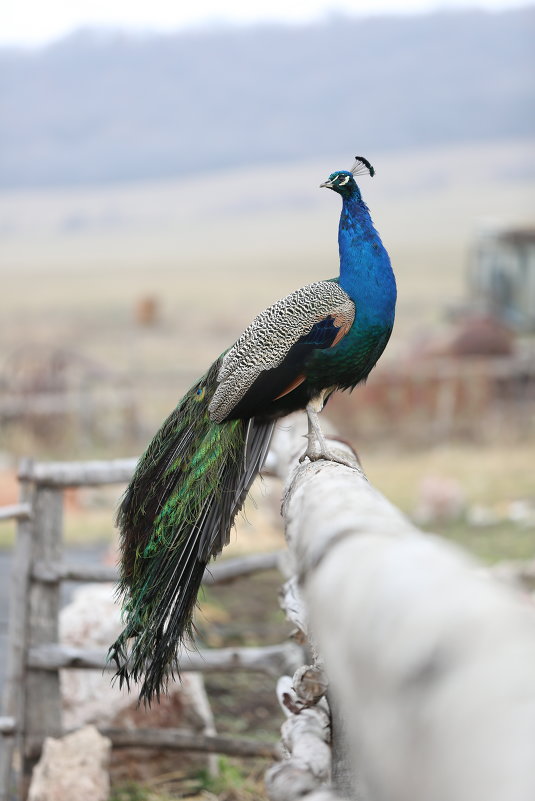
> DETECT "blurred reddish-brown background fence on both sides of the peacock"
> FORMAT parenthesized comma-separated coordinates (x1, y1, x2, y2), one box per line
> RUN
(0, 352, 535, 454)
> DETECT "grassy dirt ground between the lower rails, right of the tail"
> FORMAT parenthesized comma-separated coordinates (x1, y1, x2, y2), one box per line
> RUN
(111, 570, 290, 801)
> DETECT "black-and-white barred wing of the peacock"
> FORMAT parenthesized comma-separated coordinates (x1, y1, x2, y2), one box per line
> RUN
(209, 281, 355, 423)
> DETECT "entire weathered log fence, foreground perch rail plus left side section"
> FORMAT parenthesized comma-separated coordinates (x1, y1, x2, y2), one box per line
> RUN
(0, 422, 535, 801)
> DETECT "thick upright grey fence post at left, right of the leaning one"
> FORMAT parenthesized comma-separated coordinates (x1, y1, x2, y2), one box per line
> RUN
(22, 484, 63, 784)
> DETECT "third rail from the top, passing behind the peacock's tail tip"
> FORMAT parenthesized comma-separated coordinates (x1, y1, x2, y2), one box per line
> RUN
(28, 642, 301, 676)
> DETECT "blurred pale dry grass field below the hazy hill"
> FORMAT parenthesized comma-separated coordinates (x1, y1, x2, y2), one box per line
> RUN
(0, 141, 535, 371)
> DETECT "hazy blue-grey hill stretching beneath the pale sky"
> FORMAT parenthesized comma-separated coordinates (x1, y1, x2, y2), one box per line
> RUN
(0, 7, 535, 187)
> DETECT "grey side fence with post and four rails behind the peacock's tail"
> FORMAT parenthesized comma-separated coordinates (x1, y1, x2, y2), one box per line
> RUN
(0, 460, 302, 801)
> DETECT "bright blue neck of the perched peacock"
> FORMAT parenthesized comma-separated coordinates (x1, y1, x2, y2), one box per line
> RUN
(338, 187, 396, 326)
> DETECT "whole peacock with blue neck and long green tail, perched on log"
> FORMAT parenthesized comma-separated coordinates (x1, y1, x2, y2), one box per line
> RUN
(109, 156, 396, 703)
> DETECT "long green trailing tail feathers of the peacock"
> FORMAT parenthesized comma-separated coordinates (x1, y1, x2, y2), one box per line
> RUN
(109, 360, 273, 703)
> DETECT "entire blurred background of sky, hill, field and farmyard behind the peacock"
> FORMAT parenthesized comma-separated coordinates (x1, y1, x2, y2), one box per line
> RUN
(0, 0, 535, 792)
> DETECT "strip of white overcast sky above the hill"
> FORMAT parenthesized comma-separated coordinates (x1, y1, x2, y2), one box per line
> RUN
(0, 0, 531, 45)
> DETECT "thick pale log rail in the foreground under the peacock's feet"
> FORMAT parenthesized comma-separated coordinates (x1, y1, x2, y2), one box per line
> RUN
(278, 418, 535, 801)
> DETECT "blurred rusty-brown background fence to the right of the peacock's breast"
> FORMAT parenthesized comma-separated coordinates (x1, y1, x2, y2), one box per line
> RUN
(329, 353, 535, 446)
